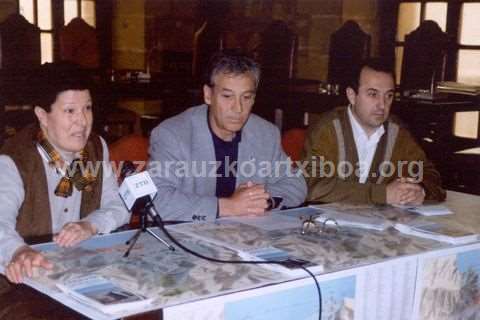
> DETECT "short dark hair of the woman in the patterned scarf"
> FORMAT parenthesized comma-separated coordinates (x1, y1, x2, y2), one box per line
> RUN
(31, 61, 93, 112)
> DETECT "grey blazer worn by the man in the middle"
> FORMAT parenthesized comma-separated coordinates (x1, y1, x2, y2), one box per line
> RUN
(148, 105, 307, 221)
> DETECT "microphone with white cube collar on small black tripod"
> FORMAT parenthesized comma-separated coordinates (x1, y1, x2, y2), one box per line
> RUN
(118, 161, 175, 251)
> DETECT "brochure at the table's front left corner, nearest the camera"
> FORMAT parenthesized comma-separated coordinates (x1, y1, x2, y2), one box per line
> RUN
(57, 274, 152, 314)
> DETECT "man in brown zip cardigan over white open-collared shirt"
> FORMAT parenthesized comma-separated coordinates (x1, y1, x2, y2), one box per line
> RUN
(304, 59, 445, 205)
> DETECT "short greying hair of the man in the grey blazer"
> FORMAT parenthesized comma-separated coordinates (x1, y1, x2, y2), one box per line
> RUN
(204, 50, 260, 87)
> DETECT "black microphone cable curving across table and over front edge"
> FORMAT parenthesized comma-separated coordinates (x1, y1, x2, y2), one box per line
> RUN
(148, 205, 322, 320)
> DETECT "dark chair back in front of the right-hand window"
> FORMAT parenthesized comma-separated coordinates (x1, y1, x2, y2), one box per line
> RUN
(400, 20, 448, 94)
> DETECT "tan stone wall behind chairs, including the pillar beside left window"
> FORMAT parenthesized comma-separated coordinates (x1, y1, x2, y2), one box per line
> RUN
(112, 0, 380, 80)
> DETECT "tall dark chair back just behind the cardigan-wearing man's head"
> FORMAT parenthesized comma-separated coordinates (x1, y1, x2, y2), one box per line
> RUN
(327, 20, 370, 94)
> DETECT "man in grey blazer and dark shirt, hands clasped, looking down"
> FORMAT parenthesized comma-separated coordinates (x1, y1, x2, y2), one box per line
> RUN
(149, 53, 307, 221)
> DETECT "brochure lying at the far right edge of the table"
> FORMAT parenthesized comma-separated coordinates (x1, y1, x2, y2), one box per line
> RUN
(394, 220, 480, 244)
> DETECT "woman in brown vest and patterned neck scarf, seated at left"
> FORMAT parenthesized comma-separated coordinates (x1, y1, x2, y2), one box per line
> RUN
(0, 63, 130, 288)
